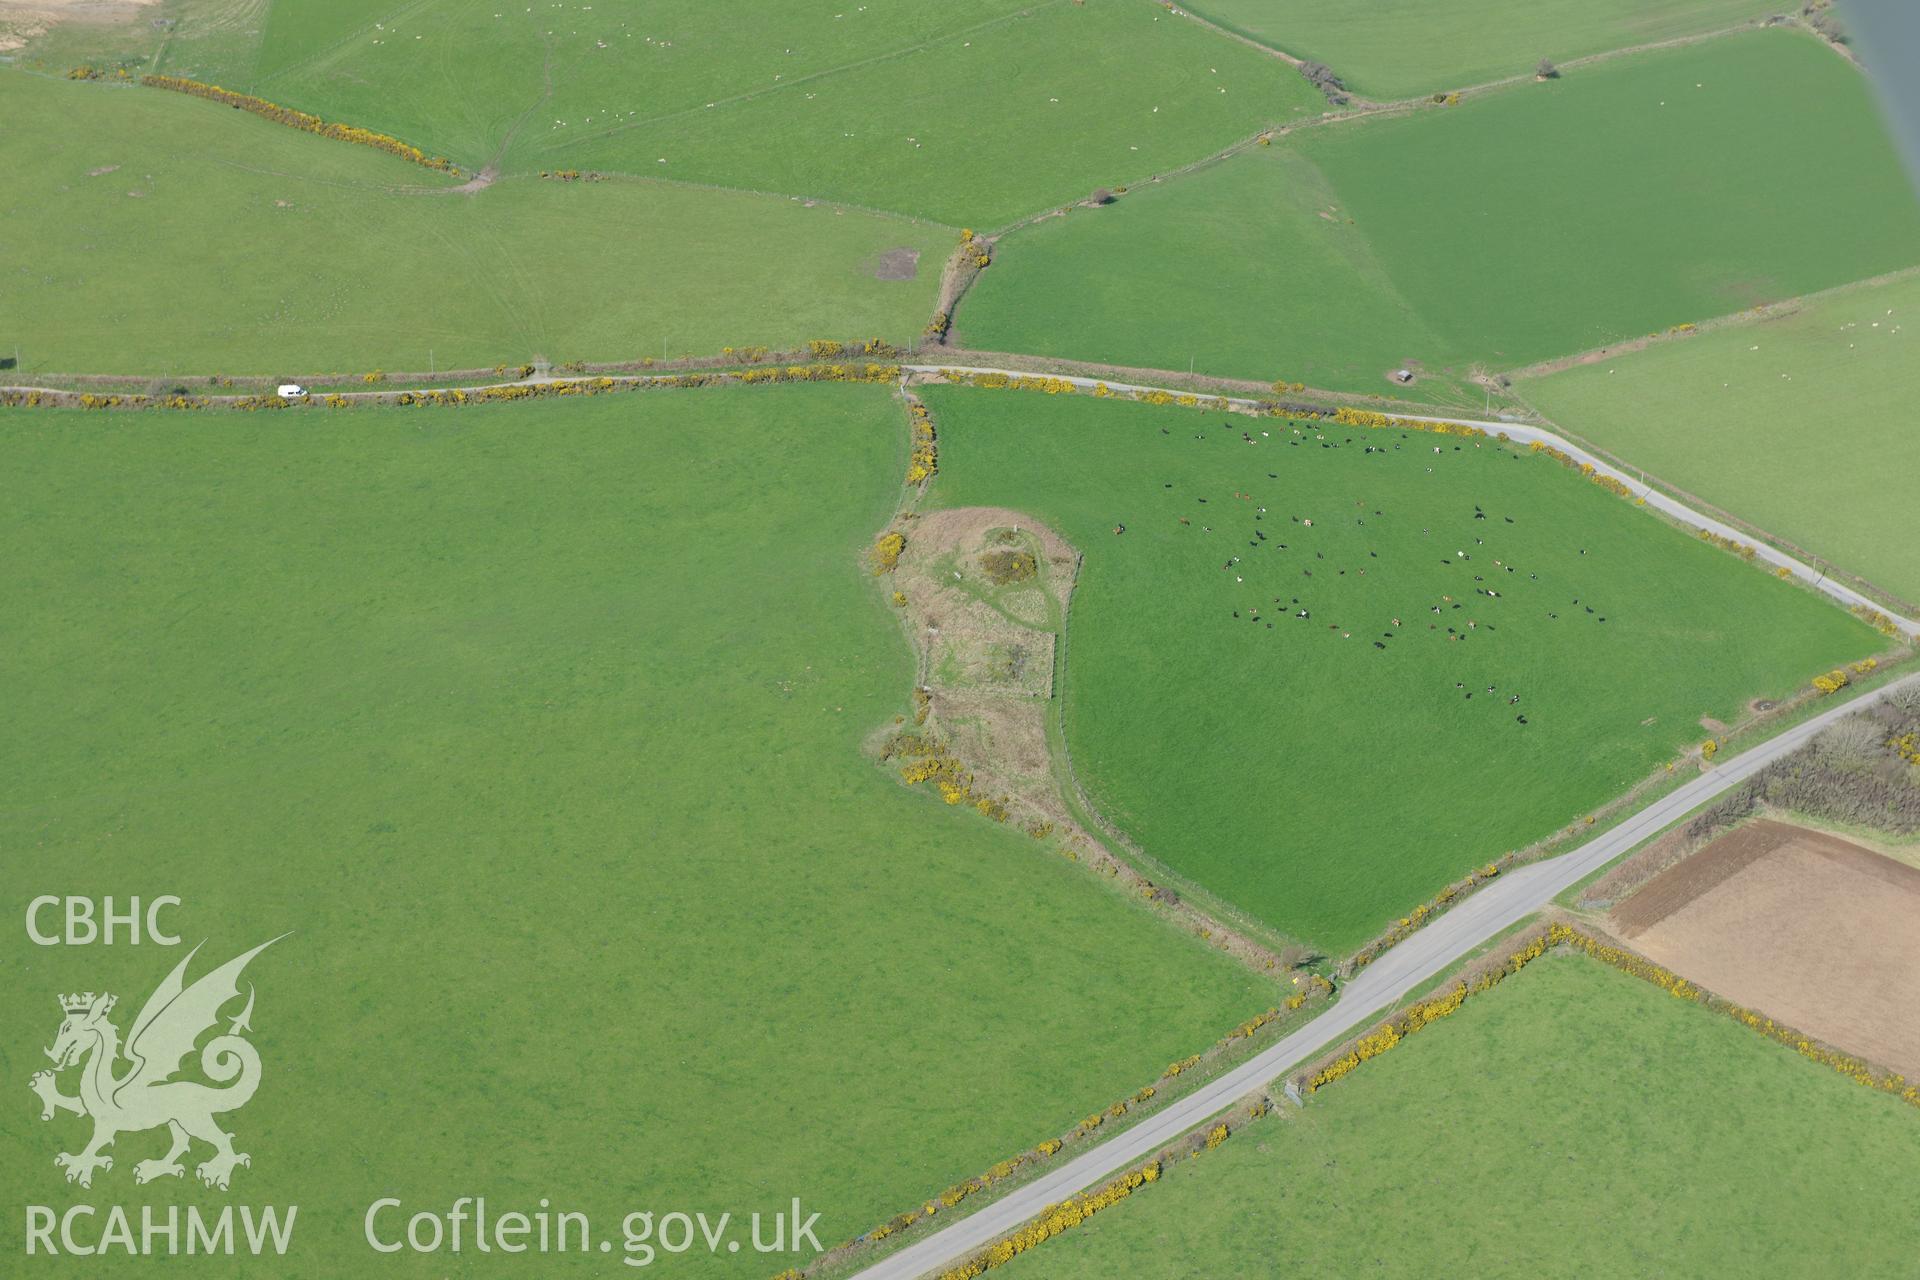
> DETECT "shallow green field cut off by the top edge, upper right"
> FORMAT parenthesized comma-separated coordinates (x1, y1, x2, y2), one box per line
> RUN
(1198, 0, 1780, 100)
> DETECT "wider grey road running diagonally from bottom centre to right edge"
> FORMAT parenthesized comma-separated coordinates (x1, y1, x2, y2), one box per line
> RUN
(854, 671, 1920, 1280)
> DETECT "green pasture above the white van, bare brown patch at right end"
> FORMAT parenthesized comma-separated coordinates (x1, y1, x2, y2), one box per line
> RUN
(0, 73, 956, 374)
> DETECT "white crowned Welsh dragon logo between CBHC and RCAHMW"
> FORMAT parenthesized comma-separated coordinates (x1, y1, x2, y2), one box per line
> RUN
(29, 935, 286, 1190)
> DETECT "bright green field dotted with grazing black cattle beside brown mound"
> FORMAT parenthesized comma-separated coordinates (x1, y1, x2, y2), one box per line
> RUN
(925, 388, 1880, 954)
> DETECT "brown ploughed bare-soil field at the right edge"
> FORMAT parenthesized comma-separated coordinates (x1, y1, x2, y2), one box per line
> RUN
(1613, 819, 1920, 1079)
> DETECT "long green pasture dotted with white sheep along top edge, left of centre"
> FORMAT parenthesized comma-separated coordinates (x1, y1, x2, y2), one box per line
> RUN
(45, 0, 1327, 230)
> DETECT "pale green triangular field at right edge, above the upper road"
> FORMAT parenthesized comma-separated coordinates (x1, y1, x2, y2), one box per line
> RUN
(1517, 276, 1920, 601)
